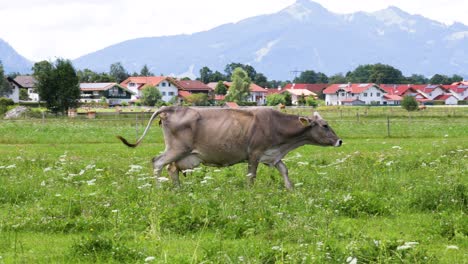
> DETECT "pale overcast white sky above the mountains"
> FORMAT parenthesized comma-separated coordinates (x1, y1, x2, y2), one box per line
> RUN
(0, 0, 468, 61)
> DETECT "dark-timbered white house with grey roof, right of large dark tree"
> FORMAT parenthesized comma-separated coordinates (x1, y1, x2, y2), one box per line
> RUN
(80, 83, 134, 105)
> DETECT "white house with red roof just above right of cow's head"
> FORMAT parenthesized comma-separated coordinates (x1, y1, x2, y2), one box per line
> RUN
(323, 83, 387, 105)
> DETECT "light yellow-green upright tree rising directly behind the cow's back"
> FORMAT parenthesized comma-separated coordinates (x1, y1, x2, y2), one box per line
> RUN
(226, 67, 251, 103)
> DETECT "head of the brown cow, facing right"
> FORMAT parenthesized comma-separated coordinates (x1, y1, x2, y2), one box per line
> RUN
(299, 112, 343, 147)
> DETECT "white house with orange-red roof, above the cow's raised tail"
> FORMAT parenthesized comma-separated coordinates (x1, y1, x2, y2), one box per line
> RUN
(120, 76, 179, 102)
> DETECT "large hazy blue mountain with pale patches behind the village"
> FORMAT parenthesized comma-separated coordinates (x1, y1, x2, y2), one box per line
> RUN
(0, 0, 468, 80)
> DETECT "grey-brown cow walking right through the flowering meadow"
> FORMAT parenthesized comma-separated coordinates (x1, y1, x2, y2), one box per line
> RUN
(118, 106, 342, 189)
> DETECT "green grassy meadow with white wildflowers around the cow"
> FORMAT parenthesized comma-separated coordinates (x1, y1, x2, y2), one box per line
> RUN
(0, 107, 468, 263)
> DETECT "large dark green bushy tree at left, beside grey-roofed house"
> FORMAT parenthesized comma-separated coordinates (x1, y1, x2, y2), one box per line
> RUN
(33, 59, 81, 113)
